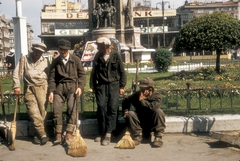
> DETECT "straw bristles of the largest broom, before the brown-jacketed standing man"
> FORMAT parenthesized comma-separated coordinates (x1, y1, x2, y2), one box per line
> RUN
(68, 129, 87, 157)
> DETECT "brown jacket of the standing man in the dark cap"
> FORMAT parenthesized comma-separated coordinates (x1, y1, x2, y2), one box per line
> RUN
(48, 54, 86, 92)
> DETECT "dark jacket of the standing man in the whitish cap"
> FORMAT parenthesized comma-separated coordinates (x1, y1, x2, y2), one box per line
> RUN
(90, 52, 127, 90)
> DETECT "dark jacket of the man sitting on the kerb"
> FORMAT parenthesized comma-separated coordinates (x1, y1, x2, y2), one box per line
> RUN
(122, 91, 162, 115)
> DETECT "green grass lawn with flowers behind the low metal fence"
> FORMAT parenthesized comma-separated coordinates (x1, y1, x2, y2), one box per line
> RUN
(0, 65, 240, 118)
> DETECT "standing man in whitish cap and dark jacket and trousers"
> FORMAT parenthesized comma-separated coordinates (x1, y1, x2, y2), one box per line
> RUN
(90, 37, 127, 146)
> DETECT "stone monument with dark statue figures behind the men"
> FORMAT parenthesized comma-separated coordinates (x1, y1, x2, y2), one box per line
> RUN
(85, 0, 154, 63)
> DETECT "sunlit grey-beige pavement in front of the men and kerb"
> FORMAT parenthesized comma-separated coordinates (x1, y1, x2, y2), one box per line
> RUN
(0, 133, 240, 161)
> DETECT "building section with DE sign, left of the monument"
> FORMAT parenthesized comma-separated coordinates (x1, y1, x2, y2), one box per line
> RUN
(39, 0, 89, 50)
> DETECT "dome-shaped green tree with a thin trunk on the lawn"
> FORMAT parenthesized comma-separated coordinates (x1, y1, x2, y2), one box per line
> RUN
(173, 11, 240, 73)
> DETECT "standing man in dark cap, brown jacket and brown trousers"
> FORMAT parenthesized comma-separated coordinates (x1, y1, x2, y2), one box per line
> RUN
(48, 39, 86, 145)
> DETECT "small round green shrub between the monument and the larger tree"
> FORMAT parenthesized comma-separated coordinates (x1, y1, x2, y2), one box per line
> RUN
(152, 49, 172, 72)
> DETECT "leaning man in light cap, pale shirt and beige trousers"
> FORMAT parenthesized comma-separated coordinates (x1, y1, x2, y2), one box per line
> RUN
(13, 43, 49, 145)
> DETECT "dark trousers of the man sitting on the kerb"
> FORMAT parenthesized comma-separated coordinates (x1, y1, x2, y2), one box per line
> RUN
(126, 108, 166, 136)
